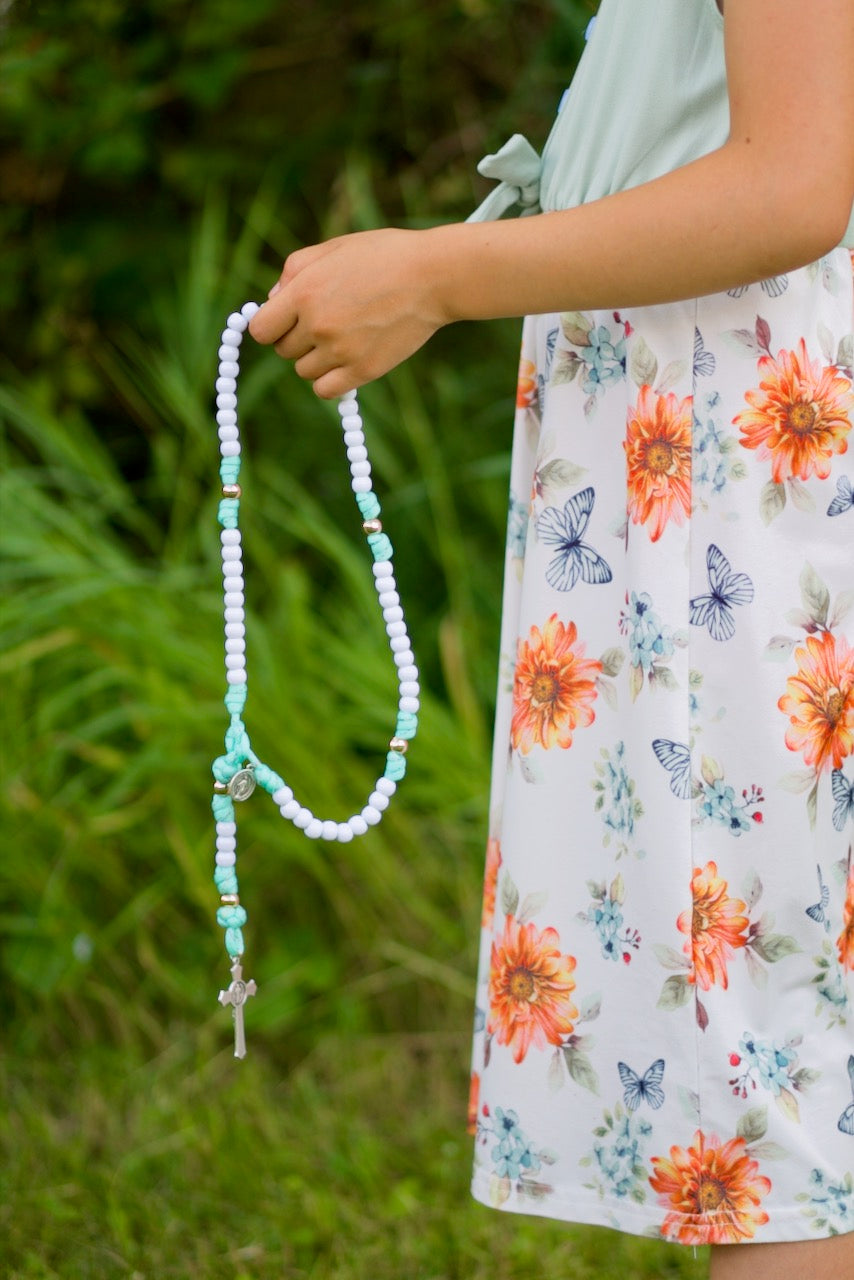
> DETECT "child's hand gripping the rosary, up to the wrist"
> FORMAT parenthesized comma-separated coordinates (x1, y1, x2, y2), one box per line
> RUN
(250, 230, 448, 399)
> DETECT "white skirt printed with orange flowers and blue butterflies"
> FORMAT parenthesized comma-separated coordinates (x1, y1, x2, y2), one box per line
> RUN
(470, 5, 854, 1244)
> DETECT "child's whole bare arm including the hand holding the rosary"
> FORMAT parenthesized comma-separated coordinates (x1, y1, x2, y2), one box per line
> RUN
(250, 0, 854, 397)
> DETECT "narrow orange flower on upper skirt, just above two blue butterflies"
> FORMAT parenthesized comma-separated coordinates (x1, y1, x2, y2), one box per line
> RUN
(625, 387, 693, 543)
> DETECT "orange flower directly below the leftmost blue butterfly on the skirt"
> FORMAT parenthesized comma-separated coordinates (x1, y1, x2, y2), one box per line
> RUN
(510, 613, 602, 755)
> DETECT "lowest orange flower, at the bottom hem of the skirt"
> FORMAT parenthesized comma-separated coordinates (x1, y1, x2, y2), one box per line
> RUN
(649, 1129, 771, 1244)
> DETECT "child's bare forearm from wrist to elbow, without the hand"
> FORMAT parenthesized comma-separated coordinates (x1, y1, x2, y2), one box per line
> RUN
(428, 141, 850, 321)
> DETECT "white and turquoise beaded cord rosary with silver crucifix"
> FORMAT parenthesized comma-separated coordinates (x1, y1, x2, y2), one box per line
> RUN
(211, 302, 419, 1057)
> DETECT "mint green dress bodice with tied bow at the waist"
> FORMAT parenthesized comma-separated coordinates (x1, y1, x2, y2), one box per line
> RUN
(472, 0, 854, 246)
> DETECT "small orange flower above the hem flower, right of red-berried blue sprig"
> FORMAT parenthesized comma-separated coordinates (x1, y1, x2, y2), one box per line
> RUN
(676, 863, 750, 991)
